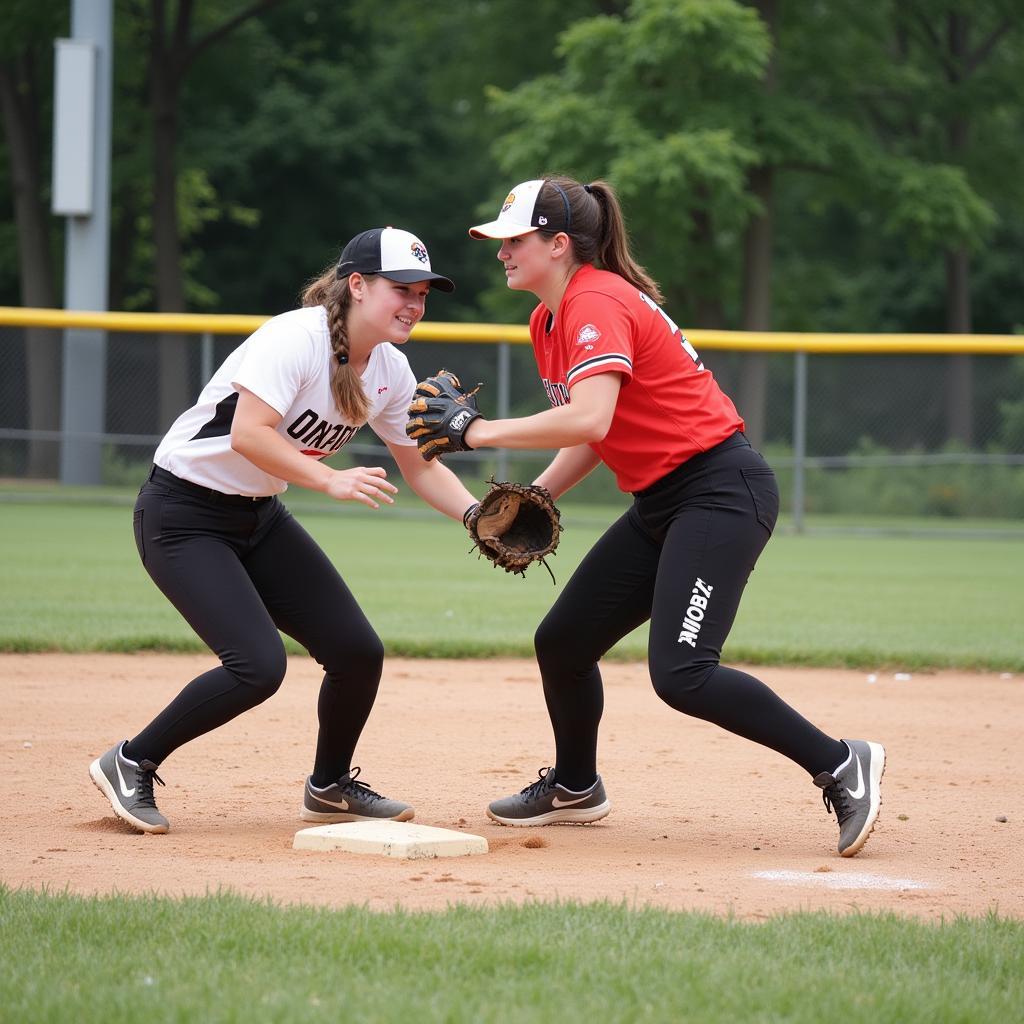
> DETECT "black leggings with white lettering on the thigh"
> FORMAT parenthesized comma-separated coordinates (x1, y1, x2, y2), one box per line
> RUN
(535, 433, 847, 790)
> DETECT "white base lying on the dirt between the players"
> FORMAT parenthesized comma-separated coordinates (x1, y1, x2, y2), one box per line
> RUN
(292, 821, 487, 860)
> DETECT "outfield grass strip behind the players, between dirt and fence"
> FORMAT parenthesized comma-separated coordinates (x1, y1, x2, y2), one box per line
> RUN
(0, 496, 1024, 671)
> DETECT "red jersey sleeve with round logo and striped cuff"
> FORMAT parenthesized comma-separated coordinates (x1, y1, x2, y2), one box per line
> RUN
(561, 292, 636, 389)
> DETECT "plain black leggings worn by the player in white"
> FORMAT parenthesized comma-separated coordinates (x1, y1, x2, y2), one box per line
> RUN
(126, 469, 384, 784)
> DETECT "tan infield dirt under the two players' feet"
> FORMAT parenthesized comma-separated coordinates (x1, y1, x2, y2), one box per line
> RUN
(0, 654, 1024, 920)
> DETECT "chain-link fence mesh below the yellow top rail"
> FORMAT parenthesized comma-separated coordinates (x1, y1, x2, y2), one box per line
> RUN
(0, 326, 1024, 532)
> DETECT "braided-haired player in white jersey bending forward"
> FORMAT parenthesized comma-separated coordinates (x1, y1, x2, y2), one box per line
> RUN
(90, 227, 473, 833)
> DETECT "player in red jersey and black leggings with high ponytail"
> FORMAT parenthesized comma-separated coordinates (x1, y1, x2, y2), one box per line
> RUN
(465, 177, 885, 856)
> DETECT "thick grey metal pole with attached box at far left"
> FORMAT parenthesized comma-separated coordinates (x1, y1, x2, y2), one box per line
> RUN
(55, 0, 114, 483)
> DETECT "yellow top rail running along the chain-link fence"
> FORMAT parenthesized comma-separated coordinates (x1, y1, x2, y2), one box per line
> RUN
(0, 306, 1024, 355)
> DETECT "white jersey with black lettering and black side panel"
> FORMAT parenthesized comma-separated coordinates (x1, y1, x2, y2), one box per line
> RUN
(154, 306, 416, 498)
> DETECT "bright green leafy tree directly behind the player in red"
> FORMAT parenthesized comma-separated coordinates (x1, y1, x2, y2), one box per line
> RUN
(483, 0, 790, 443)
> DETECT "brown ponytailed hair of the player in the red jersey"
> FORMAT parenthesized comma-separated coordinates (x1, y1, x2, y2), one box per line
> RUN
(537, 174, 665, 304)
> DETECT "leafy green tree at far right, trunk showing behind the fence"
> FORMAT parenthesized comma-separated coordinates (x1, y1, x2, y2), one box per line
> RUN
(812, 0, 1024, 443)
